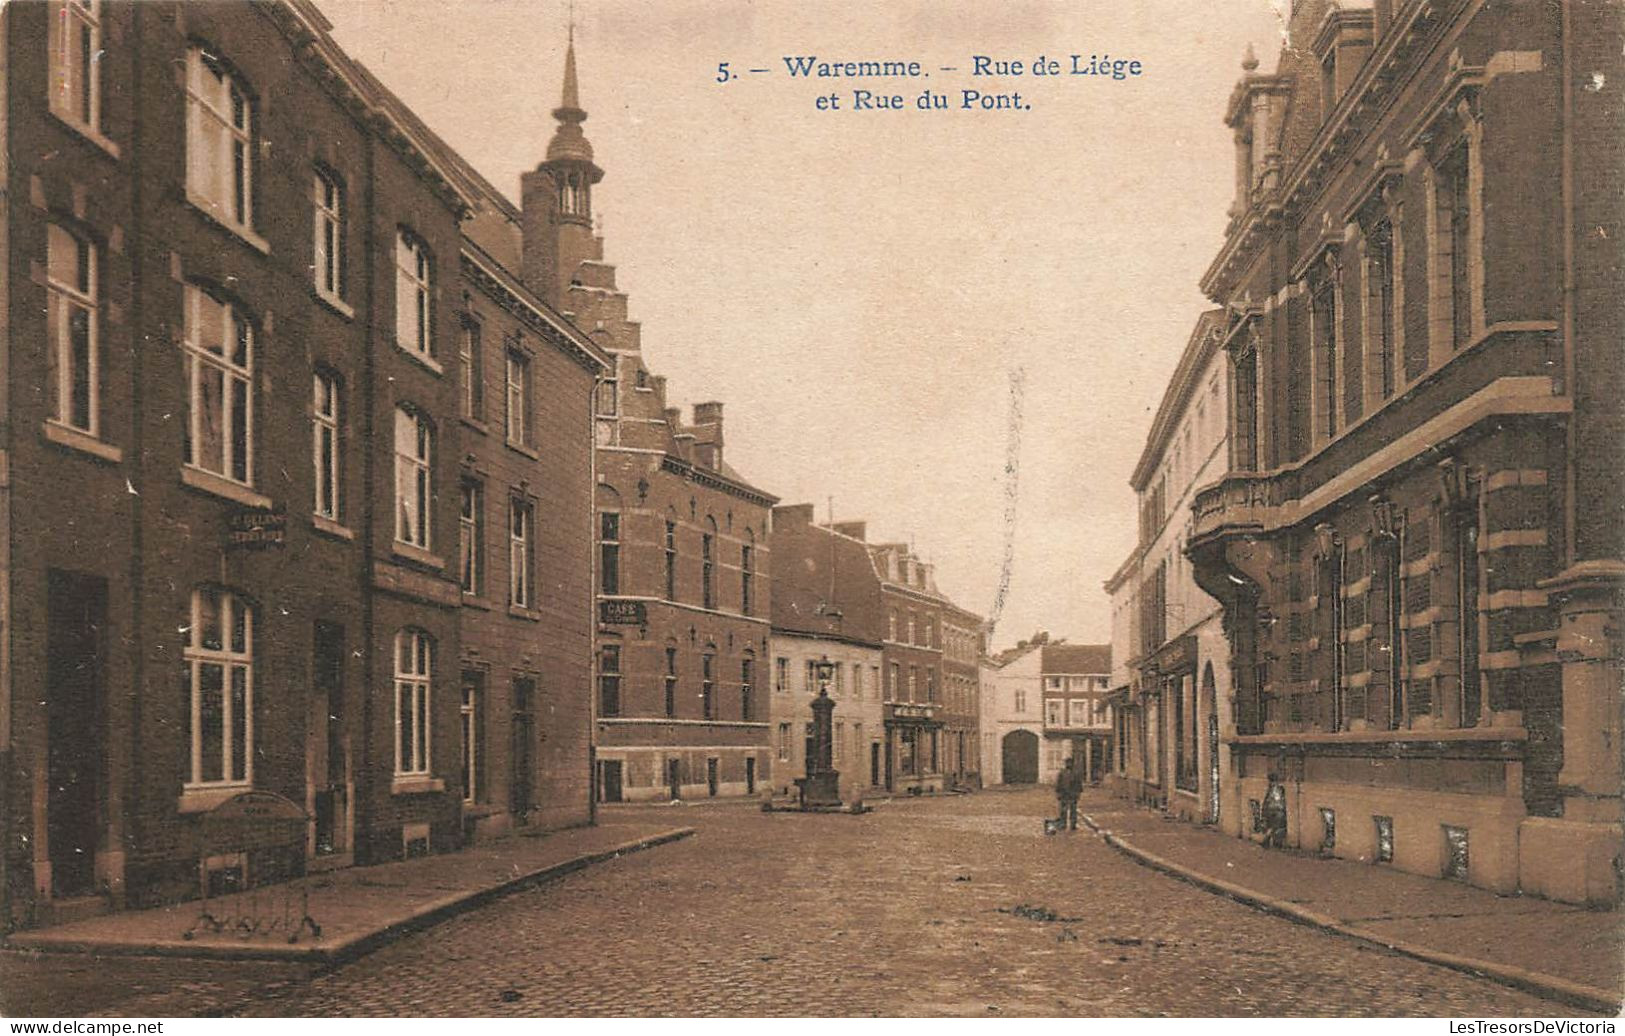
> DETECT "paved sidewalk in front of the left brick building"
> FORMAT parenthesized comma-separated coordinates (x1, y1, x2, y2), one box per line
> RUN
(5, 817, 694, 966)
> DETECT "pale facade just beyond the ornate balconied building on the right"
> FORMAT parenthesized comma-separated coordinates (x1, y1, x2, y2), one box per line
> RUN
(1107, 310, 1240, 830)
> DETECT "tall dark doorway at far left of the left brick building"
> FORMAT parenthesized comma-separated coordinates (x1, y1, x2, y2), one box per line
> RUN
(46, 570, 107, 898)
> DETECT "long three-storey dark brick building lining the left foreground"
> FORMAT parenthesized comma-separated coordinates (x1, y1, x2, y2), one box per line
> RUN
(0, 0, 606, 924)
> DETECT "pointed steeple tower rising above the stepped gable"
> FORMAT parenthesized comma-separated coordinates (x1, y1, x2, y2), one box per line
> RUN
(520, 24, 605, 309)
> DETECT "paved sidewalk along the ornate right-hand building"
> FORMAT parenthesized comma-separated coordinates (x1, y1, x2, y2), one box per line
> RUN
(1081, 792, 1625, 1013)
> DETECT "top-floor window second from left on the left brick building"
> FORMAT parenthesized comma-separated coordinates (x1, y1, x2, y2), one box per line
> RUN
(187, 47, 254, 229)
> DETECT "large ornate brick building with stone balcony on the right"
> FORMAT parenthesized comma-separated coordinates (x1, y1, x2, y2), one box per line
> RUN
(1188, 0, 1625, 903)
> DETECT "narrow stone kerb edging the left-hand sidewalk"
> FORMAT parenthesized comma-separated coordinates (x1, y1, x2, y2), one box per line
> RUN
(7, 828, 694, 969)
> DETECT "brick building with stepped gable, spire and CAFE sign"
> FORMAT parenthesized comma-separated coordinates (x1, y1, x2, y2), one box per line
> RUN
(522, 44, 775, 802)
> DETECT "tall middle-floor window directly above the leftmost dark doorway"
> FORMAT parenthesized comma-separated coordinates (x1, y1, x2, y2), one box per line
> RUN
(46, 225, 101, 435)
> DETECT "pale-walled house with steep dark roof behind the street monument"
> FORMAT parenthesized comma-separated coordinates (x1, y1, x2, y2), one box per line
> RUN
(770, 503, 886, 802)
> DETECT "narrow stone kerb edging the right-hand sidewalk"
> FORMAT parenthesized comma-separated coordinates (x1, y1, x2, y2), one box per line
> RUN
(1081, 814, 1622, 1017)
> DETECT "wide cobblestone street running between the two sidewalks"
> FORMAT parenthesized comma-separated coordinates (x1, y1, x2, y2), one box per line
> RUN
(149, 791, 1573, 1017)
